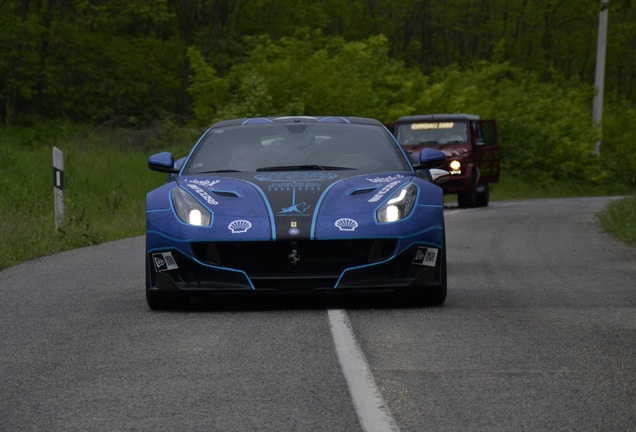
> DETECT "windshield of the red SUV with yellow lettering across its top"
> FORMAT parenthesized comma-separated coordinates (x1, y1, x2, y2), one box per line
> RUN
(397, 121, 468, 146)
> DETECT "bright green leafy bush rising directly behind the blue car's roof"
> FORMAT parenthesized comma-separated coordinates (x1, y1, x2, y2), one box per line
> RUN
(191, 30, 423, 123)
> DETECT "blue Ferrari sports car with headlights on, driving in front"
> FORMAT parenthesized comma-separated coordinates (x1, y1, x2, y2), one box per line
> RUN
(146, 117, 446, 309)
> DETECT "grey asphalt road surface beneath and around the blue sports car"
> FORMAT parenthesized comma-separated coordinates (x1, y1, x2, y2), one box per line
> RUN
(0, 198, 636, 432)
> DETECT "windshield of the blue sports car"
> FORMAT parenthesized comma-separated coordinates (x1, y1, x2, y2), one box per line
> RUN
(184, 123, 410, 174)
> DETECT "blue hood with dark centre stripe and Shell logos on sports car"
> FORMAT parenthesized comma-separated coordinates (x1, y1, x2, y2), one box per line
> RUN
(149, 171, 442, 240)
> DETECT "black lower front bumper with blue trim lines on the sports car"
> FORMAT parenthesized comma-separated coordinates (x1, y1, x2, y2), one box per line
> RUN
(146, 240, 446, 293)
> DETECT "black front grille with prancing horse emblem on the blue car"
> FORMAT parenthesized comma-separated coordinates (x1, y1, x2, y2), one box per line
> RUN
(192, 239, 397, 280)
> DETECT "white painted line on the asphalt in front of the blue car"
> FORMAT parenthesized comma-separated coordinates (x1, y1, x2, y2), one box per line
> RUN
(328, 309, 400, 432)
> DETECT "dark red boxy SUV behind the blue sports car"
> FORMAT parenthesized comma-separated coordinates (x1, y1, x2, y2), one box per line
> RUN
(393, 114, 499, 207)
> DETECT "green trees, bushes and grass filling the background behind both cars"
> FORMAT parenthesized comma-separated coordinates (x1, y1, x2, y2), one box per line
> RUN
(0, 0, 636, 268)
